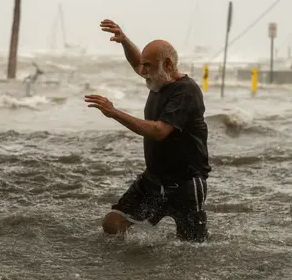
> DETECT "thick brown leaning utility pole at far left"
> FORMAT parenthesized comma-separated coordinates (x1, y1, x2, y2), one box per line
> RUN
(7, 0, 21, 79)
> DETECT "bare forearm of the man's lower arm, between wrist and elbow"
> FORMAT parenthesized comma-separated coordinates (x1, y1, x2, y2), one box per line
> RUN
(113, 110, 159, 139)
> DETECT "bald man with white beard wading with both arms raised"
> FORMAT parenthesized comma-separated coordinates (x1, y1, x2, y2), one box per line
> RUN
(85, 19, 211, 242)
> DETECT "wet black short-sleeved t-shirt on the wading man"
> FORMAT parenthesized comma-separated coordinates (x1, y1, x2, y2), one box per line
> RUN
(144, 75, 211, 178)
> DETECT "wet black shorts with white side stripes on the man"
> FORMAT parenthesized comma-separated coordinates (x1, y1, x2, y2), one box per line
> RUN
(112, 173, 208, 242)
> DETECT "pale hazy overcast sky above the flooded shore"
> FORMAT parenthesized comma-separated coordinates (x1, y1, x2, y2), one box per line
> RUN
(0, 0, 292, 60)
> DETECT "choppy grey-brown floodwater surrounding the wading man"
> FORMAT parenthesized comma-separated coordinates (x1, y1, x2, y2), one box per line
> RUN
(0, 53, 292, 280)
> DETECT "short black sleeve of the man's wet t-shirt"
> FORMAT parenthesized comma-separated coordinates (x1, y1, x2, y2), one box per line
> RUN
(158, 91, 193, 131)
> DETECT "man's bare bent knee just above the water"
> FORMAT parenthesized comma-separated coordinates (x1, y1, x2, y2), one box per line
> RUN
(102, 212, 132, 234)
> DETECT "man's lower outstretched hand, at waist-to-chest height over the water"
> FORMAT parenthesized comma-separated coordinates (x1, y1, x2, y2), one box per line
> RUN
(84, 95, 117, 118)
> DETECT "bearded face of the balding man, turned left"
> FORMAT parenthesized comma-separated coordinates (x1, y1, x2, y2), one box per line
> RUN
(141, 53, 171, 92)
